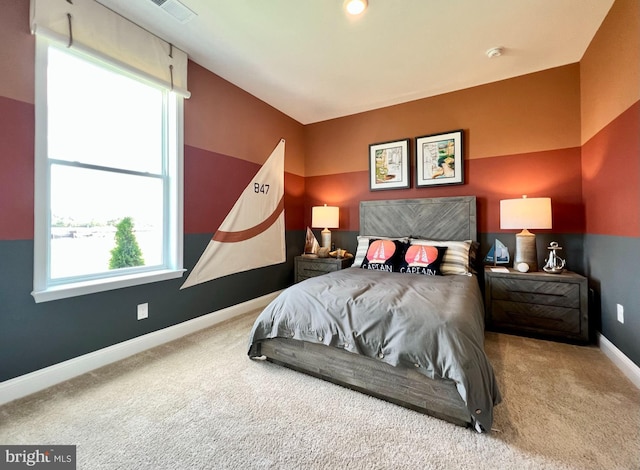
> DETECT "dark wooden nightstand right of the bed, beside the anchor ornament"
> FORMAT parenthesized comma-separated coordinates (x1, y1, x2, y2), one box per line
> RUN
(484, 267, 589, 343)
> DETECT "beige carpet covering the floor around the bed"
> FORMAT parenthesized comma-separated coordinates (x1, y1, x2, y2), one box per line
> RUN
(0, 312, 640, 470)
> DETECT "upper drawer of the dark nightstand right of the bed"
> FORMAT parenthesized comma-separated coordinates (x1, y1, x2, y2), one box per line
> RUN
(491, 278, 580, 309)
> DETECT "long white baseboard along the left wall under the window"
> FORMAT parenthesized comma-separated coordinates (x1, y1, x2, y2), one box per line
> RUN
(0, 291, 280, 405)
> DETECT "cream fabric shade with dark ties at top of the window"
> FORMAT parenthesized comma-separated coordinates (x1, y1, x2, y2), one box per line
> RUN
(31, 0, 190, 98)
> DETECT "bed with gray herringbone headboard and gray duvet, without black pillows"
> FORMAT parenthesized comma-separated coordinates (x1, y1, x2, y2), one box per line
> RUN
(248, 196, 501, 432)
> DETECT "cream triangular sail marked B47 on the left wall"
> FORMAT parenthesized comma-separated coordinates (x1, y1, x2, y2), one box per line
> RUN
(180, 139, 286, 289)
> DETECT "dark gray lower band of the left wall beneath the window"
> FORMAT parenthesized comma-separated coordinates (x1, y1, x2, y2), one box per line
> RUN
(0, 232, 304, 382)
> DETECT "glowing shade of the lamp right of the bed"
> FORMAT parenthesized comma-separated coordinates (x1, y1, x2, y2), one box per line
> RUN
(500, 196, 551, 230)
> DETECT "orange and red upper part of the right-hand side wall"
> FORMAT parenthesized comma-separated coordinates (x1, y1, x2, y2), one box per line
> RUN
(580, 0, 640, 237)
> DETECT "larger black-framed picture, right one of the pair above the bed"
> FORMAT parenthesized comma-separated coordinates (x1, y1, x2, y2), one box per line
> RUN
(416, 130, 464, 188)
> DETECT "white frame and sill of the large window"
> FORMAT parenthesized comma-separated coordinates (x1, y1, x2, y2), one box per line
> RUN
(31, 35, 185, 303)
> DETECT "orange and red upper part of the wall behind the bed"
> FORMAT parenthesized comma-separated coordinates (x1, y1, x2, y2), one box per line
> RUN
(305, 64, 585, 233)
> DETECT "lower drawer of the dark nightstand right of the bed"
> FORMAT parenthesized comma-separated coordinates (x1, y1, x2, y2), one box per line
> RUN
(491, 299, 581, 335)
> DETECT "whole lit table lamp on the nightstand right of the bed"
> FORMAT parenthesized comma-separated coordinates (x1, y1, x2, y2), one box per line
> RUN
(500, 195, 551, 271)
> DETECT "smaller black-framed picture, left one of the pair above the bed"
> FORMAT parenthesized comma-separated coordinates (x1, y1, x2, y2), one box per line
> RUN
(369, 139, 410, 191)
